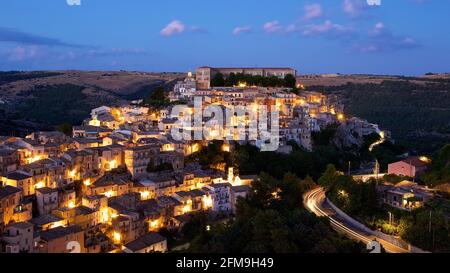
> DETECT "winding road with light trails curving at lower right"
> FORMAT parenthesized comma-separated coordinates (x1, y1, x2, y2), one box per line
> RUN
(303, 188, 416, 253)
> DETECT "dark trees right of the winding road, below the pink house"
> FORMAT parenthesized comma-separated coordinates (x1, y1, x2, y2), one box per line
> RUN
(318, 165, 450, 252)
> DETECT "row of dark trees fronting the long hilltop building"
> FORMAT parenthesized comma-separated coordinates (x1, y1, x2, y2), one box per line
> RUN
(211, 73, 296, 88)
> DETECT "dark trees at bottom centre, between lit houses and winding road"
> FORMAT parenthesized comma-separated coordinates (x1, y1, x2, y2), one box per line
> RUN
(185, 173, 365, 253)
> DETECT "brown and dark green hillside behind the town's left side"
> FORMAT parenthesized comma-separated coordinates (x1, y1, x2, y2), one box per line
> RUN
(0, 71, 185, 135)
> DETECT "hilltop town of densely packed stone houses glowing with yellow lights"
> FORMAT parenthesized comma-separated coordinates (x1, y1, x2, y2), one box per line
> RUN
(0, 67, 412, 253)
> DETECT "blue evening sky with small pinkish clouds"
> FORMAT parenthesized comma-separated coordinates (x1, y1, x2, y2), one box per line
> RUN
(0, 0, 450, 75)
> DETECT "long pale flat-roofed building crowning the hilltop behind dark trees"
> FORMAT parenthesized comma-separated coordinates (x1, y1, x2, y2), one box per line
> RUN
(196, 66, 297, 89)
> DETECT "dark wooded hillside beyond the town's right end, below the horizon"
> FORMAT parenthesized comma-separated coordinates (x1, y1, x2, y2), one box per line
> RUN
(314, 78, 450, 153)
